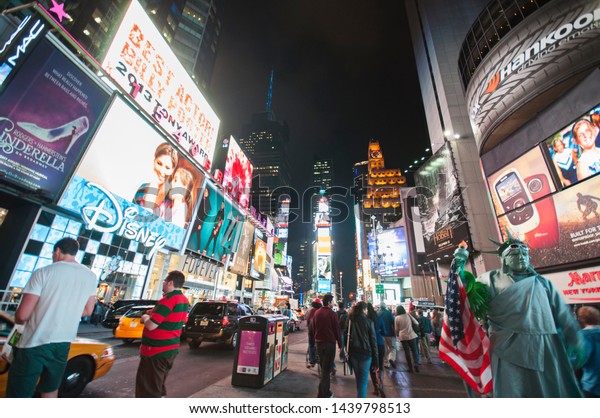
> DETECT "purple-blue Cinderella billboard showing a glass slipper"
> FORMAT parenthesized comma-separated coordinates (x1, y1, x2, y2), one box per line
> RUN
(0, 39, 110, 200)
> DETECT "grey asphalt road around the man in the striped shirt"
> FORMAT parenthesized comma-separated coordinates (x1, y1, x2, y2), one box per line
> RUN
(80, 328, 307, 398)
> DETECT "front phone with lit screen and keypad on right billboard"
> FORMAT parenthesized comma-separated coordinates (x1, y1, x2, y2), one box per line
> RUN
(494, 169, 540, 234)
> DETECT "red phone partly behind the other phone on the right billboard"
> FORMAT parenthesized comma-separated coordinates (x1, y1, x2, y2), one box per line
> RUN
(524, 174, 558, 248)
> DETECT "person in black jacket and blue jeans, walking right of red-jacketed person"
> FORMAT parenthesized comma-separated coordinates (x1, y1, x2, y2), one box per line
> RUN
(348, 301, 379, 398)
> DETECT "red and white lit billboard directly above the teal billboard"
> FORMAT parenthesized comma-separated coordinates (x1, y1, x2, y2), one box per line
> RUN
(213, 136, 253, 209)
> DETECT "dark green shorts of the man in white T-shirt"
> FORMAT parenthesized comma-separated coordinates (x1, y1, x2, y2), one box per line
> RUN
(6, 343, 71, 398)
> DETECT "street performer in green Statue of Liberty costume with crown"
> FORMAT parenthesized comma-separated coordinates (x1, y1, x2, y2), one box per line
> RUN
(454, 233, 584, 398)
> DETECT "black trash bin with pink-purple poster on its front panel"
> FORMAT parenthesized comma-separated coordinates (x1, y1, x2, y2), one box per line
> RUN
(231, 315, 289, 388)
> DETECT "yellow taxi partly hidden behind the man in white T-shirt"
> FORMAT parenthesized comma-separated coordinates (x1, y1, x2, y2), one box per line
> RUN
(0, 312, 115, 398)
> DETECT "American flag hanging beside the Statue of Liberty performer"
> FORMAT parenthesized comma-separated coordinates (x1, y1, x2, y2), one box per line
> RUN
(439, 261, 492, 394)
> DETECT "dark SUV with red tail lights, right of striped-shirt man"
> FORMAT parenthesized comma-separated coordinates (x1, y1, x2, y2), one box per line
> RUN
(182, 300, 254, 349)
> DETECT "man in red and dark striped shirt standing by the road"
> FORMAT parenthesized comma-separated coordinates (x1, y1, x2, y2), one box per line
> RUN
(135, 270, 190, 398)
